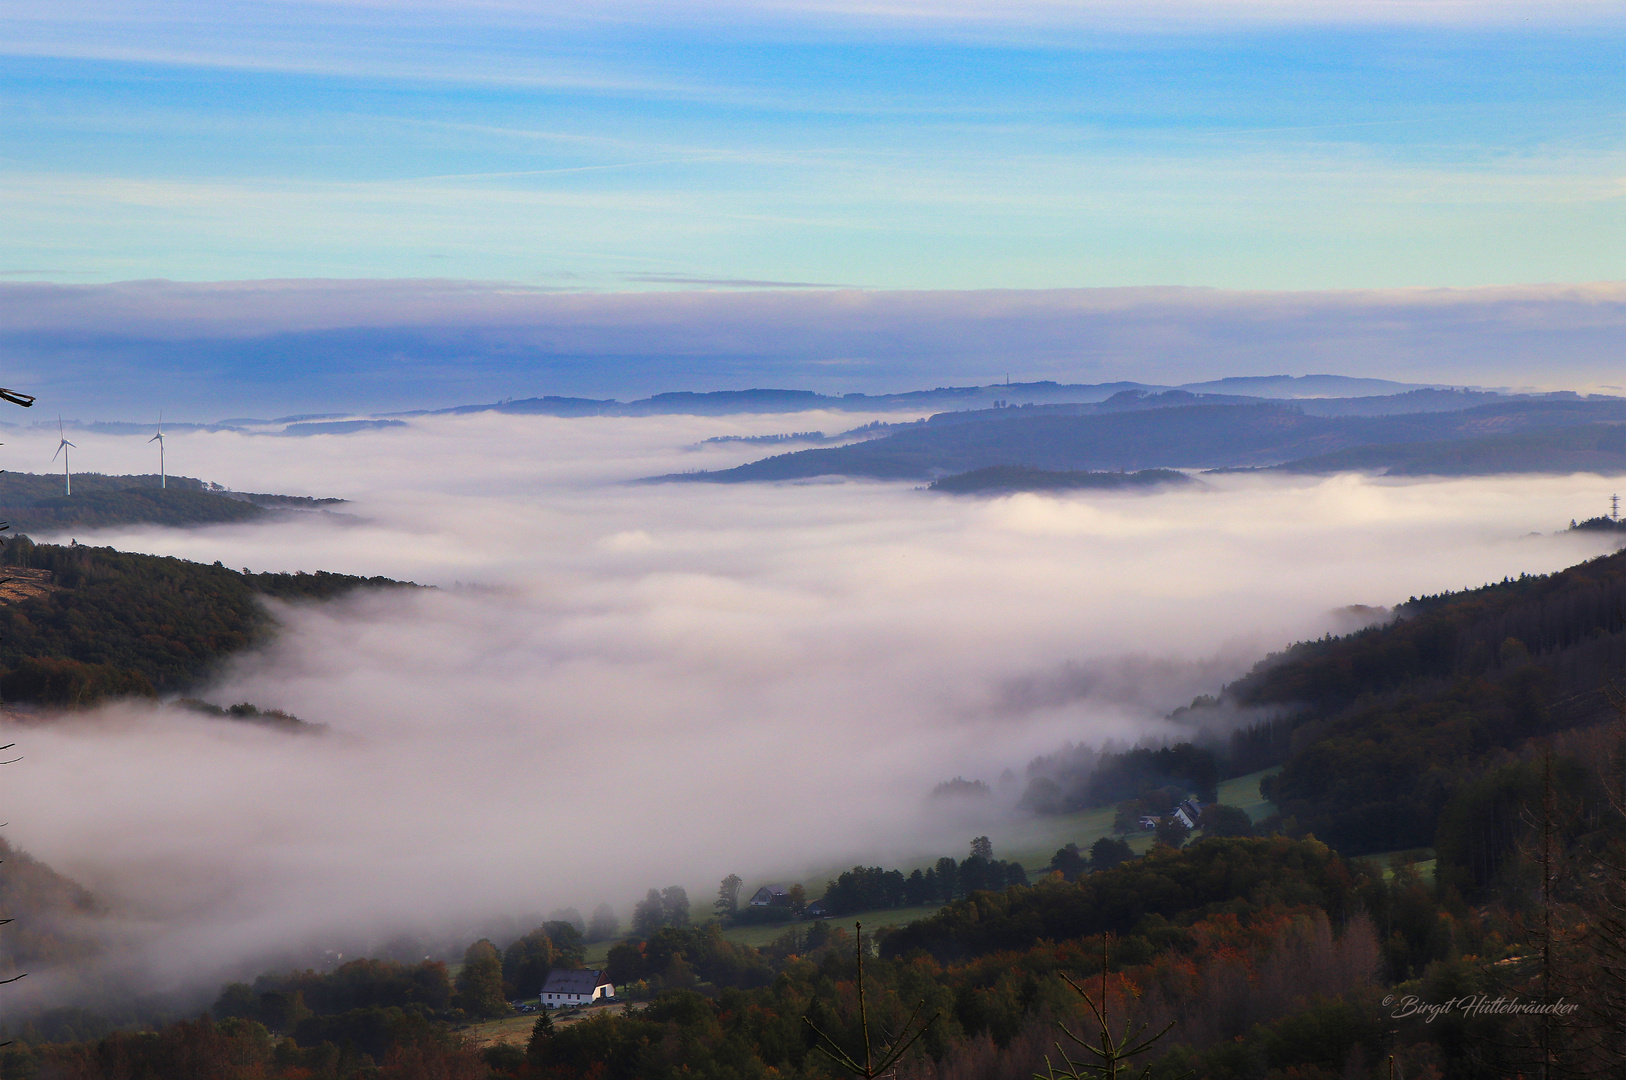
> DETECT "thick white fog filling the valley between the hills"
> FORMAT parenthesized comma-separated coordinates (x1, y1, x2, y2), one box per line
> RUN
(7, 415, 1610, 1001)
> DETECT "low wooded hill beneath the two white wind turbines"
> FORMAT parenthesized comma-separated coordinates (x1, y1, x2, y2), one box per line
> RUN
(0, 472, 286, 532)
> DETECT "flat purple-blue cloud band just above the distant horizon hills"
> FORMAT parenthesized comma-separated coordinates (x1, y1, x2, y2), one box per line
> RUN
(0, 281, 1626, 420)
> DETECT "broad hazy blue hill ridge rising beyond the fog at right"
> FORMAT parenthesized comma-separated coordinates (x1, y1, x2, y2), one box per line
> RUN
(663, 395, 1626, 483)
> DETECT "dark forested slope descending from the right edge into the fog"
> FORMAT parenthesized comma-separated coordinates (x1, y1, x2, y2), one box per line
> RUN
(1224, 551, 1626, 854)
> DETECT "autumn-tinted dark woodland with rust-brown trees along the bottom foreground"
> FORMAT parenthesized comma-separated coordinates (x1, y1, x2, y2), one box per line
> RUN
(0, 836, 1537, 1080)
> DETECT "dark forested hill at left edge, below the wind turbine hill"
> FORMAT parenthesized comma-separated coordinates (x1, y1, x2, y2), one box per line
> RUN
(0, 535, 415, 704)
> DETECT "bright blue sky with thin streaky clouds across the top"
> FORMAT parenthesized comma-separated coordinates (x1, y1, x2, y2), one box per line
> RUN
(0, 0, 1626, 291)
